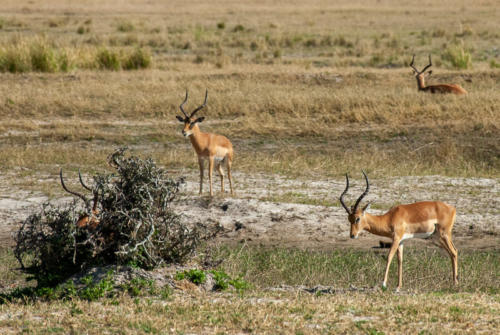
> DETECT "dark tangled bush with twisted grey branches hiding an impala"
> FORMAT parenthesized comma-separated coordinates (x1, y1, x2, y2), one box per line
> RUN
(15, 149, 220, 285)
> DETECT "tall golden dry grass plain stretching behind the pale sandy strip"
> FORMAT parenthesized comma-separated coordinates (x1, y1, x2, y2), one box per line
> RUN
(0, 0, 500, 180)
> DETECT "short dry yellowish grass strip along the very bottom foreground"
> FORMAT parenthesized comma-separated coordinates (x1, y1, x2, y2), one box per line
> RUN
(0, 292, 500, 334)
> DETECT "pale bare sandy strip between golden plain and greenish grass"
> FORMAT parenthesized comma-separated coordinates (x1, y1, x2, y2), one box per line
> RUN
(0, 171, 500, 249)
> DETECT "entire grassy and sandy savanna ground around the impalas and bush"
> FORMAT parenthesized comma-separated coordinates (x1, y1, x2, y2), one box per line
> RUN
(0, 0, 500, 334)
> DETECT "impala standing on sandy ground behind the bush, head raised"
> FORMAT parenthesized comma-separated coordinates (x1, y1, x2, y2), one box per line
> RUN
(176, 90, 234, 196)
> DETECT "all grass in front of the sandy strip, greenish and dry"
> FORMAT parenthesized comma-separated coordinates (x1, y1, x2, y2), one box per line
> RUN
(0, 246, 500, 334)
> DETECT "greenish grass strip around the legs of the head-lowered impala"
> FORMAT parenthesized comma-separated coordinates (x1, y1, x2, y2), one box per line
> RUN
(219, 247, 500, 294)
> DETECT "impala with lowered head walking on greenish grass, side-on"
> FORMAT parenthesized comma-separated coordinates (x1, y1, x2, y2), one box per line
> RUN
(340, 171, 458, 290)
